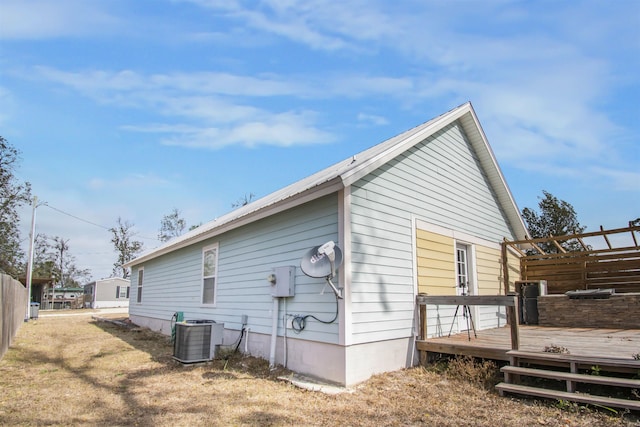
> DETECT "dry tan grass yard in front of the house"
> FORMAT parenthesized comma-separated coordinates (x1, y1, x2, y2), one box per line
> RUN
(0, 316, 640, 427)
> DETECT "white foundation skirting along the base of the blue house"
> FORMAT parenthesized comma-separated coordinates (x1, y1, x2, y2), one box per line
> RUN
(130, 315, 418, 387)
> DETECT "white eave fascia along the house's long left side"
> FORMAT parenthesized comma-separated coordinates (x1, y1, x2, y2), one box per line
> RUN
(123, 179, 344, 268)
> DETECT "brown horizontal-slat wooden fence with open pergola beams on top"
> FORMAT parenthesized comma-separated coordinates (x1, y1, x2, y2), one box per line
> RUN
(502, 226, 640, 294)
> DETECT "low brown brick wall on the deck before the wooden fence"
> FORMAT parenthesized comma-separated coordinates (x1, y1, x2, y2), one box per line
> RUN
(538, 293, 640, 329)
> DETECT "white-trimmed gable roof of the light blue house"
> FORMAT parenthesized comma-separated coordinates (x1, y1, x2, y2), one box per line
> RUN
(125, 102, 528, 267)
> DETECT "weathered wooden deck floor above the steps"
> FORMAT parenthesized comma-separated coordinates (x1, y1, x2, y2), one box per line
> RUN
(417, 325, 640, 369)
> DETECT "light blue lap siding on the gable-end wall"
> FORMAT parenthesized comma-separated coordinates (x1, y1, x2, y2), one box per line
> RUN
(344, 119, 511, 343)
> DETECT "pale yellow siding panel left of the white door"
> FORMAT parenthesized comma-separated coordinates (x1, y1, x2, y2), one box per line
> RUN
(416, 229, 456, 295)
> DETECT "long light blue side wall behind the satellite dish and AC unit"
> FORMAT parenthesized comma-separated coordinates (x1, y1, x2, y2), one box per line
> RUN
(129, 194, 344, 383)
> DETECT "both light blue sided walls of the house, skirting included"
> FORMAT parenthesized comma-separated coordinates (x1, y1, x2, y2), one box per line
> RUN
(129, 118, 513, 385)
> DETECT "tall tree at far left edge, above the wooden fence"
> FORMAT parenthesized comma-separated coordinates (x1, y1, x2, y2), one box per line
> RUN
(0, 136, 31, 277)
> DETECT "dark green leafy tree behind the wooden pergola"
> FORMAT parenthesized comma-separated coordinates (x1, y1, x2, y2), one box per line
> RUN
(522, 190, 587, 253)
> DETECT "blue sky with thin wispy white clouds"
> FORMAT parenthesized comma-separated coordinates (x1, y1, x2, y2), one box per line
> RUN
(0, 0, 640, 278)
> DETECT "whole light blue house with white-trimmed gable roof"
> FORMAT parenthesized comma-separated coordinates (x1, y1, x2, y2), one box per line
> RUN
(127, 103, 527, 386)
